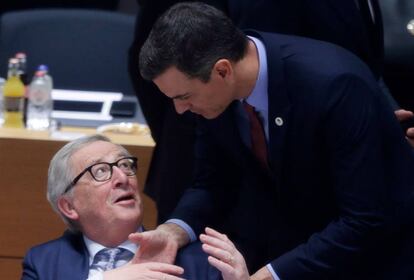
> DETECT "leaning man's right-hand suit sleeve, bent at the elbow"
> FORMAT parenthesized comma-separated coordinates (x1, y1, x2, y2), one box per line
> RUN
(271, 76, 412, 280)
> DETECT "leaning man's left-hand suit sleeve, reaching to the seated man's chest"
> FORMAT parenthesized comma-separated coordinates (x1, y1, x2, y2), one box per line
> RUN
(172, 118, 239, 235)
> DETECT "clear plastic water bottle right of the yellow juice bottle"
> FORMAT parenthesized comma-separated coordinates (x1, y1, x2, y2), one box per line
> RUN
(26, 71, 53, 130)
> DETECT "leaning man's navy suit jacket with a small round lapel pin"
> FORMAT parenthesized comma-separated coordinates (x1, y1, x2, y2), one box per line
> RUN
(173, 32, 414, 280)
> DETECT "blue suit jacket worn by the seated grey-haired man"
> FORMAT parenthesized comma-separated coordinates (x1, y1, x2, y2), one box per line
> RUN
(21, 231, 221, 280)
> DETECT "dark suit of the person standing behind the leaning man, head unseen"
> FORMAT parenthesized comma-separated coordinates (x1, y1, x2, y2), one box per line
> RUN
(129, 0, 397, 221)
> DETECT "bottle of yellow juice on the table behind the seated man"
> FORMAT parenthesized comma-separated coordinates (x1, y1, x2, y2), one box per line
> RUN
(3, 58, 25, 128)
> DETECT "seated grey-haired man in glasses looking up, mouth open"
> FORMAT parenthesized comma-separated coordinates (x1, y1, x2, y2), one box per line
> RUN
(22, 135, 220, 280)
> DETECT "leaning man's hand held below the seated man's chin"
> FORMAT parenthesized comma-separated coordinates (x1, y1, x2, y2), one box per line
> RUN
(129, 224, 189, 264)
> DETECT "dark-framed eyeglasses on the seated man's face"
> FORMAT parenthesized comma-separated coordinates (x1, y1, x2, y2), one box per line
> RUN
(63, 157, 138, 193)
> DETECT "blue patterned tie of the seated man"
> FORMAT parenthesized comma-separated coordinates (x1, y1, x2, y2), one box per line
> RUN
(90, 248, 134, 271)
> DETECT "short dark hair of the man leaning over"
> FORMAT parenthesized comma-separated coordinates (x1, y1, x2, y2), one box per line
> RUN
(139, 2, 248, 82)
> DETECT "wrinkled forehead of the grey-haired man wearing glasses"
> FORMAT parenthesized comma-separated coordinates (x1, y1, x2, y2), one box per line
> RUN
(70, 141, 130, 172)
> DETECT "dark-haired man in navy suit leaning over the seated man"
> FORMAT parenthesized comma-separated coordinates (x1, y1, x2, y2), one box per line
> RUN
(133, 3, 414, 280)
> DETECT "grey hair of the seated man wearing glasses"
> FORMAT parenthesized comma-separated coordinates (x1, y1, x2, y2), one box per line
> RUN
(46, 134, 128, 232)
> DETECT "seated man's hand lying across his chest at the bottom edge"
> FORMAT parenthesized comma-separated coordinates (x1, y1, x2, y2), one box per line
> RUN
(103, 263, 184, 280)
